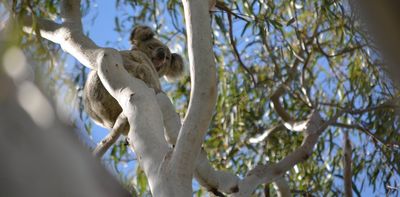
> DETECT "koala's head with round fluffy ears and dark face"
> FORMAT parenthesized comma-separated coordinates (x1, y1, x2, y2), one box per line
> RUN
(130, 26, 184, 80)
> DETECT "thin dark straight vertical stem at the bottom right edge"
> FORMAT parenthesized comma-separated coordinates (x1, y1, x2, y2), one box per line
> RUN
(343, 131, 353, 197)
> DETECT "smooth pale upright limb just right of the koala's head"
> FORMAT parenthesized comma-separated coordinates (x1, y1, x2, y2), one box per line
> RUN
(172, 0, 217, 181)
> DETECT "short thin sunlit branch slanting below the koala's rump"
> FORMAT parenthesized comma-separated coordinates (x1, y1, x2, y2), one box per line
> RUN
(93, 113, 129, 158)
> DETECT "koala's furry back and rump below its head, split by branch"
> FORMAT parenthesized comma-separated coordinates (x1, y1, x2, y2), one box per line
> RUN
(83, 50, 161, 128)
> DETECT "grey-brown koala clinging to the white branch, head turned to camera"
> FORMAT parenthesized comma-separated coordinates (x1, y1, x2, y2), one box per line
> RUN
(83, 26, 184, 135)
